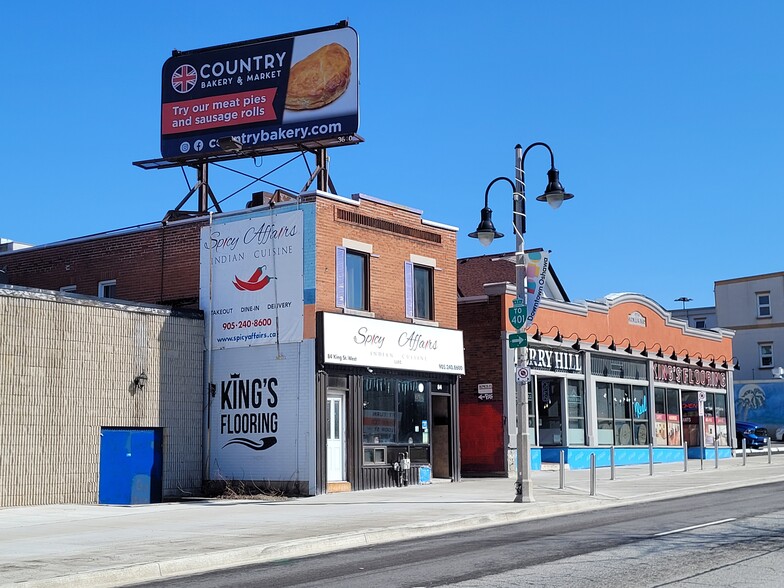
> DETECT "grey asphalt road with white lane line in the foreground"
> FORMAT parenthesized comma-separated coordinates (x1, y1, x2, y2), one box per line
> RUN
(138, 484, 784, 588)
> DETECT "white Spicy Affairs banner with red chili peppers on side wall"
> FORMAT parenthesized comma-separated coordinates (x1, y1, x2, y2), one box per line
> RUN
(200, 210, 304, 349)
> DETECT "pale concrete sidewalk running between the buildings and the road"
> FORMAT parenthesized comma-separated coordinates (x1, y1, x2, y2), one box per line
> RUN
(0, 452, 784, 587)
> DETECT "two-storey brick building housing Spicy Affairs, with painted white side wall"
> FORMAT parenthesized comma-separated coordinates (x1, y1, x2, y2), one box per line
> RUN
(0, 192, 464, 494)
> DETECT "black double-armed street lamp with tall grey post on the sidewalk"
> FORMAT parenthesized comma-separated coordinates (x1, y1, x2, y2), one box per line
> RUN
(468, 142, 573, 502)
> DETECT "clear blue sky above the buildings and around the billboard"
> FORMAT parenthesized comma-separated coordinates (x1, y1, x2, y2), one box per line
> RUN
(0, 0, 784, 308)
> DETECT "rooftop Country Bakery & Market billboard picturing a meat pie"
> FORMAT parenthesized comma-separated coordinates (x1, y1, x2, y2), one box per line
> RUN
(161, 23, 359, 158)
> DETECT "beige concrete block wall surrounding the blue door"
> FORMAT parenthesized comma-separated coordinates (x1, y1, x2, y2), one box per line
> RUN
(0, 287, 204, 506)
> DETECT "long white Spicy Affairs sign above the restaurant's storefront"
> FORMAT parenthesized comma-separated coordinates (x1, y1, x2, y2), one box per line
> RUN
(321, 312, 465, 374)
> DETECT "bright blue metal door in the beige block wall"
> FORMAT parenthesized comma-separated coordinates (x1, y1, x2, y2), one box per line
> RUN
(98, 427, 162, 504)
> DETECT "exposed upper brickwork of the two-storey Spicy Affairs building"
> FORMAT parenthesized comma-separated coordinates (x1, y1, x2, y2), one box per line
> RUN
(0, 197, 457, 326)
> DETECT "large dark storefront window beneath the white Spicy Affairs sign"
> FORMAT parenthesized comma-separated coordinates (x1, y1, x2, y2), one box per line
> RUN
(362, 377, 430, 445)
